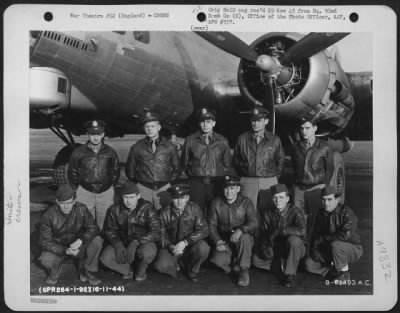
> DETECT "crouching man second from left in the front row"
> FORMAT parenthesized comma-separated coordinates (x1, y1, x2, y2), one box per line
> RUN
(100, 181, 160, 282)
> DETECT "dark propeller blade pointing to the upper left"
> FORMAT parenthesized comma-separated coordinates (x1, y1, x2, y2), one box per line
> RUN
(195, 32, 258, 62)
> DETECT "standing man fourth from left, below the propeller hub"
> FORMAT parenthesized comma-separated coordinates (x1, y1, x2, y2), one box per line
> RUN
(233, 107, 285, 219)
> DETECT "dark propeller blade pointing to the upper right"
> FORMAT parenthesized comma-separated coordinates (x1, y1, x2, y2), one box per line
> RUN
(279, 33, 350, 64)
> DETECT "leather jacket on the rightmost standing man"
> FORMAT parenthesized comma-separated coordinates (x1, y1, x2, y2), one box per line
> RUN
(292, 138, 334, 188)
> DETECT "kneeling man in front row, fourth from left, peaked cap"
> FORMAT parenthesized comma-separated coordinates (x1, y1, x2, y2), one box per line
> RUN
(208, 176, 258, 286)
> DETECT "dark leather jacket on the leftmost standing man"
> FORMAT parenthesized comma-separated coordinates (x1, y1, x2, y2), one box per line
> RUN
(69, 143, 120, 193)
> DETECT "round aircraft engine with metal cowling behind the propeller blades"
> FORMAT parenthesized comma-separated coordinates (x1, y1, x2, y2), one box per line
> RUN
(238, 33, 354, 135)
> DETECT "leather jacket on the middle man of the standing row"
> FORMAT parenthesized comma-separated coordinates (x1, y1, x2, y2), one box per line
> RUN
(181, 132, 233, 177)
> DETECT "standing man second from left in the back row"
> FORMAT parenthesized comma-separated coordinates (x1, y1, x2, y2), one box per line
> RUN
(125, 111, 181, 210)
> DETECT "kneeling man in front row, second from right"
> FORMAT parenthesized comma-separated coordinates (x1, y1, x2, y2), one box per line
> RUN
(253, 184, 306, 287)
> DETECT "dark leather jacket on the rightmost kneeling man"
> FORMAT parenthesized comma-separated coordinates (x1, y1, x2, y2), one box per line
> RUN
(311, 203, 361, 248)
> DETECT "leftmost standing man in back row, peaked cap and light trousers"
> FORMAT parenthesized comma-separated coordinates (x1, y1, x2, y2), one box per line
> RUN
(69, 120, 120, 229)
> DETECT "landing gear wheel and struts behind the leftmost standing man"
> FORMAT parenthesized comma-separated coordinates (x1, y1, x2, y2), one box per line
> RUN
(50, 127, 81, 187)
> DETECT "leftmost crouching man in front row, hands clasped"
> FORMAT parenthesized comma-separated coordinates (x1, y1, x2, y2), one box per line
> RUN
(39, 184, 103, 285)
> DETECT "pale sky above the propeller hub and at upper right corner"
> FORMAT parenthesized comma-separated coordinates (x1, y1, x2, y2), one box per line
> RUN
(236, 33, 372, 72)
